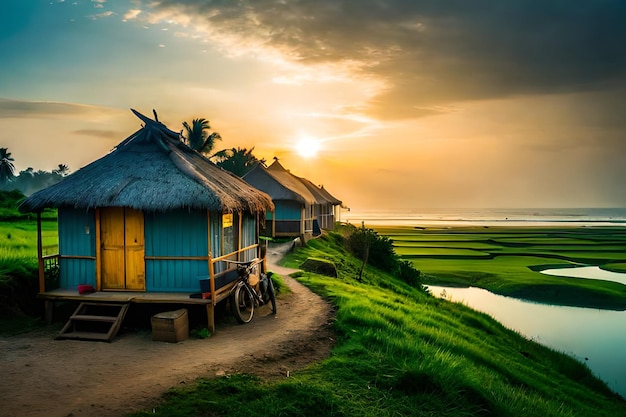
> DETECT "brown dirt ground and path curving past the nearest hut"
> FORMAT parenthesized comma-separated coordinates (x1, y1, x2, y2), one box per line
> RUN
(0, 242, 333, 417)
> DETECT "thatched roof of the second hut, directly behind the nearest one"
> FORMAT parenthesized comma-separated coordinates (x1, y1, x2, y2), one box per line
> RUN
(243, 160, 317, 204)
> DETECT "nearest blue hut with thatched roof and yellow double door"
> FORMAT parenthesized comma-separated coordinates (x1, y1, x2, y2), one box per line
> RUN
(20, 112, 274, 332)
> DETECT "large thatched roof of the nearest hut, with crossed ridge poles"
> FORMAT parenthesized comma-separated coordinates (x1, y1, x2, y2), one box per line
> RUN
(19, 110, 274, 213)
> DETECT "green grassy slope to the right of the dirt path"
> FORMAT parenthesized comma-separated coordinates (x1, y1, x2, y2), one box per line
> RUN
(128, 235, 626, 417)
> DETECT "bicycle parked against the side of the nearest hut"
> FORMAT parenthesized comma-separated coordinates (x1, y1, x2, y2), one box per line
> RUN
(225, 259, 276, 324)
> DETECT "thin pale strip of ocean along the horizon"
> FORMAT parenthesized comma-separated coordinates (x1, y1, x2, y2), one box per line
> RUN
(341, 207, 626, 227)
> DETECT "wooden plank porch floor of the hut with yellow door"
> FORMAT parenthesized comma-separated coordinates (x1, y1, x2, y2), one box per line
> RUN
(37, 289, 211, 304)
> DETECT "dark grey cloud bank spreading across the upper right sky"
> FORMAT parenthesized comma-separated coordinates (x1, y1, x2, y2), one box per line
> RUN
(149, 0, 626, 118)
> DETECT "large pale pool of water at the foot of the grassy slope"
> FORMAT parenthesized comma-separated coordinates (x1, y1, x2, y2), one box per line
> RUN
(428, 285, 626, 398)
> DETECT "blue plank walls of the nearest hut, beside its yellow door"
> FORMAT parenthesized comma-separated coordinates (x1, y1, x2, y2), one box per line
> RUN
(58, 208, 257, 292)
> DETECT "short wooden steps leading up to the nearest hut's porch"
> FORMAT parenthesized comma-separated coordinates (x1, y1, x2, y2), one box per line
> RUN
(55, 302, 130, 342)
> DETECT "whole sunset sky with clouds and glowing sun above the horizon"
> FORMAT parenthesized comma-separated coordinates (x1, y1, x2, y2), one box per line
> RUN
(0, 0, 626, 211)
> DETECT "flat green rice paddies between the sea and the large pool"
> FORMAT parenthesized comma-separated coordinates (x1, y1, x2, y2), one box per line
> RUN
(374, 226, 626, 310)
